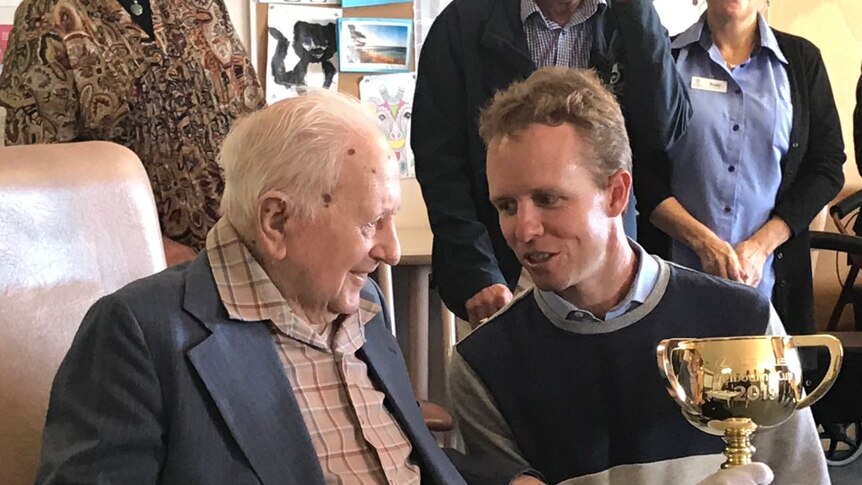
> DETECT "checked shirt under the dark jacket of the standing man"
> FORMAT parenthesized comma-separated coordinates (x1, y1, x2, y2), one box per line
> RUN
(521, 0, 605, 69)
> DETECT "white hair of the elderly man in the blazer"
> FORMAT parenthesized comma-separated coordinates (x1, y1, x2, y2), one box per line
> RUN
(218, 90, 382, 237)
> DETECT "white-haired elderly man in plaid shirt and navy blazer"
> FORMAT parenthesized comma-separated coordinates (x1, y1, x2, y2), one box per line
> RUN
(37, 92, 528, 485)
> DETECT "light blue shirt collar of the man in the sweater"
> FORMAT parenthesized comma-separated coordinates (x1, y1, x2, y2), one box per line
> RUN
(536, 239, 659, 323)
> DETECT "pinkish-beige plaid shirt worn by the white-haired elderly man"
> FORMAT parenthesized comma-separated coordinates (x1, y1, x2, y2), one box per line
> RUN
(206, 218, 419, 485)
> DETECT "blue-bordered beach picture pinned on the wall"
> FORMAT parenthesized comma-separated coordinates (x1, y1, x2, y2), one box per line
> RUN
(338, 17, 413, 72)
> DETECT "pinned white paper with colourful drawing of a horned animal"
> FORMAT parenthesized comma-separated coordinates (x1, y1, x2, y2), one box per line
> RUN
(359, 72, 416, 178)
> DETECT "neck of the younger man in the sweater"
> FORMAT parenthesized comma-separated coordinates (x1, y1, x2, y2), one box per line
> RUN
(560, 235, 638, 319)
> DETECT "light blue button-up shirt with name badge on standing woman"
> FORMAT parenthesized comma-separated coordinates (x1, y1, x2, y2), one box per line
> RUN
(669, 15, 793, 299)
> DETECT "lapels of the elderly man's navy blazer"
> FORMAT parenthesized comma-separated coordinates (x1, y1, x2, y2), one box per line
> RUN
(183, 251, 463, 485)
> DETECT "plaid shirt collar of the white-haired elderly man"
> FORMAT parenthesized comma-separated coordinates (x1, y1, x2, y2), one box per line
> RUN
(206, 217, 381, 352)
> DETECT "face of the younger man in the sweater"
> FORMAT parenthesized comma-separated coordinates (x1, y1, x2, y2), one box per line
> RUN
(488, 124, 619, 292)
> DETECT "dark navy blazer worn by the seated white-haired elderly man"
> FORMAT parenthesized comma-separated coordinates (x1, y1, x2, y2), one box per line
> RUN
(37, 252, 472, 485)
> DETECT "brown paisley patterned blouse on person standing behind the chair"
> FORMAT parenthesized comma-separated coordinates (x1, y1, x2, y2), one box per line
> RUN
(0, 0, 264, 249)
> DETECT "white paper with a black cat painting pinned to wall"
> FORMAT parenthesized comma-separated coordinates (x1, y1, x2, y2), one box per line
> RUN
(266, 4, 341, 104)
